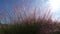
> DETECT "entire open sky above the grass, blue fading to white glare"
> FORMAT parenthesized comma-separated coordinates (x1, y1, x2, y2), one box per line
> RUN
(0, 0, 60, 23)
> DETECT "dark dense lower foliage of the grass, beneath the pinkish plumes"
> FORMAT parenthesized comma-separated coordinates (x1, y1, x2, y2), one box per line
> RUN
(0, 21, 60, 34)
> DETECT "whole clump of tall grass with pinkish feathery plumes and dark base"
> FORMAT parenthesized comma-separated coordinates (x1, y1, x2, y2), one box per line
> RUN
(0, 0, 60, 34)
